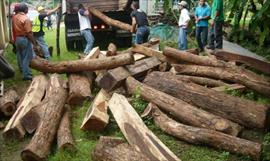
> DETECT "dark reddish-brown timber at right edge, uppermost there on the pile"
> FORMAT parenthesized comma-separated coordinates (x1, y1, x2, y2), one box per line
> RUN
(212, 50, 270, 74)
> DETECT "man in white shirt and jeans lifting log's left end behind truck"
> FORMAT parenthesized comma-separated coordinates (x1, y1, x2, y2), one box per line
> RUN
(78, 4, 95, 55)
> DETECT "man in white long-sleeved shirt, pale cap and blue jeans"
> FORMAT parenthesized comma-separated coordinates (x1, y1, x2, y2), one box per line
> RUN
(178, 1, 190, 50)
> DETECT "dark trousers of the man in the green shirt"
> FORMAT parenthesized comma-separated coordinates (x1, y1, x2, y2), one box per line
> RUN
(208, 21, 223, 49)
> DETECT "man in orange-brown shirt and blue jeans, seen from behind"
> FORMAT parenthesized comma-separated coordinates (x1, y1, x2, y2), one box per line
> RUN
(13, 3, 37, 80)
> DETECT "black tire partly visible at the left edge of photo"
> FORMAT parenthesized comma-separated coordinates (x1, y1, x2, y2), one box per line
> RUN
(0, 55, 15, 79)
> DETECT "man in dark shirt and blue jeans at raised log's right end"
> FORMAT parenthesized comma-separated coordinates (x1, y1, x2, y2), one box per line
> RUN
(130, 1, 150, 44)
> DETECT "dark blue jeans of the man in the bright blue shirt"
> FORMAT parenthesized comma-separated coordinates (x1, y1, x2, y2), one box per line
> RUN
(196, 26, 208, 50)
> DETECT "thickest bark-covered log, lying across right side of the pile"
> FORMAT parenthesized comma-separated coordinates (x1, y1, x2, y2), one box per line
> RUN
(144, 72, 269, 128)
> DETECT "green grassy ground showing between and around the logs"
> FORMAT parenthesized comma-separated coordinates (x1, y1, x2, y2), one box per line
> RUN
(0, 30, 270, 161)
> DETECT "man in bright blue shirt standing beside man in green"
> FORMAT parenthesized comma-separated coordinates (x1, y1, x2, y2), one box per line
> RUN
(195, 0, 211, 52)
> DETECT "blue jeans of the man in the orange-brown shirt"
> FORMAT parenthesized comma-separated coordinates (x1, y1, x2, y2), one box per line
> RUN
(15, 37, 34, 79)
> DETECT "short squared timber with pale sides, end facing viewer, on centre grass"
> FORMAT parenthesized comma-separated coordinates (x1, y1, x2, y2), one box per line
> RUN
(81, 89, 109, 131)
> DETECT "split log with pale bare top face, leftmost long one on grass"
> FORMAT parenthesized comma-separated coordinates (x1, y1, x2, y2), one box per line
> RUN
(3, 75, 48, 139)
